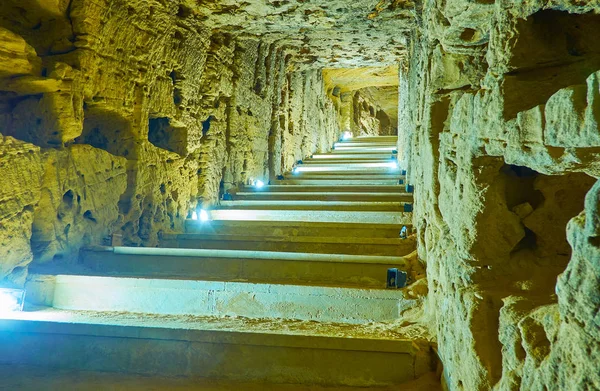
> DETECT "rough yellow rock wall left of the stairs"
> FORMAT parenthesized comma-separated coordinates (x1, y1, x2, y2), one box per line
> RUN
(0, 0, 339, 284)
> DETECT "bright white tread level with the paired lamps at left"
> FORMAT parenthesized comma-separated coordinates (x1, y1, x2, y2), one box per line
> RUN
(202, 210, 412, 225)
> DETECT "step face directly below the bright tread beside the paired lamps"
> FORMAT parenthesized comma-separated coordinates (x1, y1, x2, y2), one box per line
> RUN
(185, 220, 410, 238)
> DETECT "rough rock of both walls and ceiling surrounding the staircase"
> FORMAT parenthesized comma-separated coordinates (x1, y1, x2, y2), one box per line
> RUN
(0, 0, 600, 391)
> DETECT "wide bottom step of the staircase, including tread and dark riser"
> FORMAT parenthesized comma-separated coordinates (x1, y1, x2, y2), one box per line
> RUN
(0, 308, 434, 390)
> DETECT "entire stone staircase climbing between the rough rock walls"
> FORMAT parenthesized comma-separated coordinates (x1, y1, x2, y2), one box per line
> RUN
(0, 137, 437, 389)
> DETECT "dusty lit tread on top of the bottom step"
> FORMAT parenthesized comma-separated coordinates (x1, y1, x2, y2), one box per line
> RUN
(0, 306, 429, 353)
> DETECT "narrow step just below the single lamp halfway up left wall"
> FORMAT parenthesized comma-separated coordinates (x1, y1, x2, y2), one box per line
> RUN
(231, 191, 413, 203)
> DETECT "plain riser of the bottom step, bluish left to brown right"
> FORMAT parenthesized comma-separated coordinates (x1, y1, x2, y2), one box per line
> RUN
(0, 322, 429, 387)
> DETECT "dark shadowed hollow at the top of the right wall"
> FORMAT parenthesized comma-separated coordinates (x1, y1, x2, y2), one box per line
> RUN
(504, 10, 600, 120)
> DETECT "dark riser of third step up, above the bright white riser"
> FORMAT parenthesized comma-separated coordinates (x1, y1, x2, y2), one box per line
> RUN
(80, 251, 408, 288)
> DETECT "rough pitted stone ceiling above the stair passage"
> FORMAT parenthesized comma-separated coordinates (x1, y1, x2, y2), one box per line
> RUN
(195, 0, 415, 68)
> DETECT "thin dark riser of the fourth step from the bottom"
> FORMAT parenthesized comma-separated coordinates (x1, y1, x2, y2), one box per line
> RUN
(160, 239, 415, 257)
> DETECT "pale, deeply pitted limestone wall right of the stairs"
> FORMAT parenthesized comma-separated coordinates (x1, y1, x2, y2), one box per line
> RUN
(408, 0, 600, 391)
